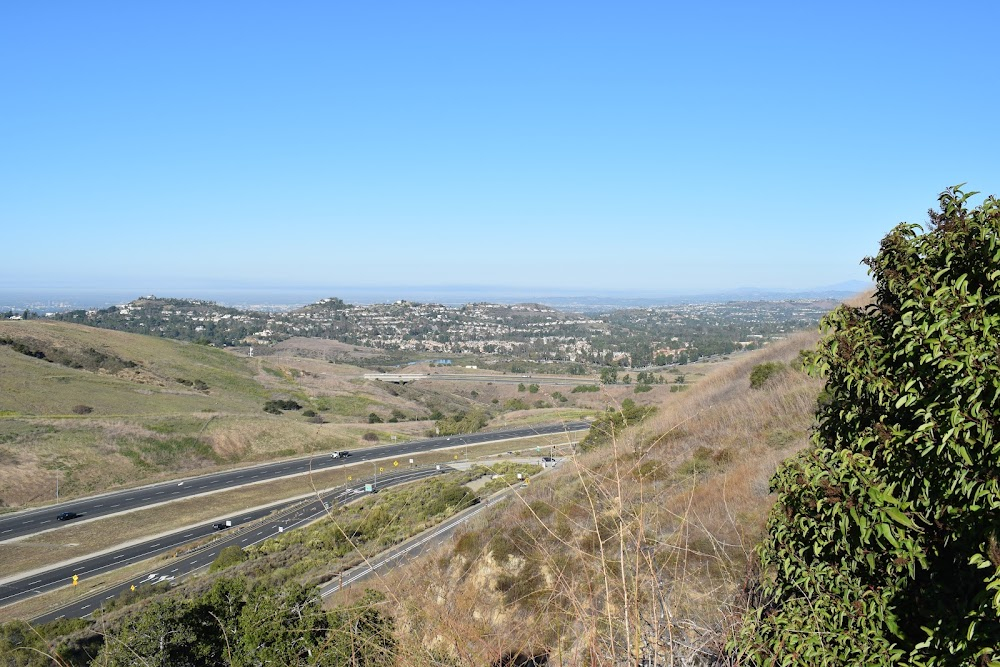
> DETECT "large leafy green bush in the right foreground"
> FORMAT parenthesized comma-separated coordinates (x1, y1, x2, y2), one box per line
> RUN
(733, 187, 1000, 667)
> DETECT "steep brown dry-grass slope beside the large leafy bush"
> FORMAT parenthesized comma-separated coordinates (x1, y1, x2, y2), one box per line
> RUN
(356, 334, 821, 665)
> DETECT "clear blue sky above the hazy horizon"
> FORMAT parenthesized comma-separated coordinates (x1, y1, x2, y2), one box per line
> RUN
(0, 0, 1000, 296)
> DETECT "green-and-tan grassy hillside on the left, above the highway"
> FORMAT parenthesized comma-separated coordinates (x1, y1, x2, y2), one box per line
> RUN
(0, 320, 592, 509)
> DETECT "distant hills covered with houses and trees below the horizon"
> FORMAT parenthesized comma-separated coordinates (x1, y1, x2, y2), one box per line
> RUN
(43, 296, 836, 372)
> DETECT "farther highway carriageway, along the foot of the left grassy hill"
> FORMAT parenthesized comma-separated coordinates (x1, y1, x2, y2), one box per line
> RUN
(0, 422, 590, 544)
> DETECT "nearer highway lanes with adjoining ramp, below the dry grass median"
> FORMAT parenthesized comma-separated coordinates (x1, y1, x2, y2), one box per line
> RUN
(21, 466, 451, 623)
